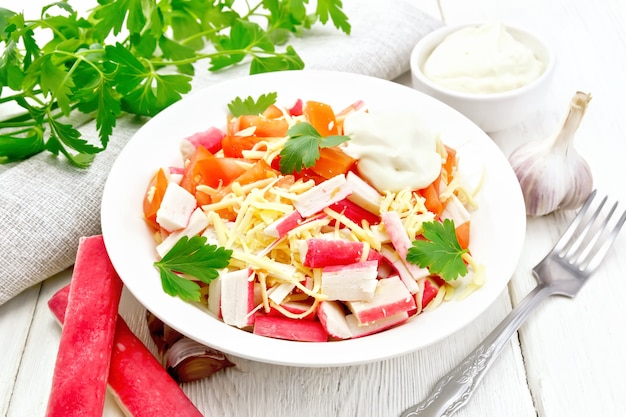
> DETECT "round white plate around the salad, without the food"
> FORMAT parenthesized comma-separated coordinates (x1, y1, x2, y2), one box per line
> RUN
(102, 71, 526, 366)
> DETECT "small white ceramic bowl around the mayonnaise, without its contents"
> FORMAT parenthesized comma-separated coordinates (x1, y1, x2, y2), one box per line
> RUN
(410, 24, 555, 132)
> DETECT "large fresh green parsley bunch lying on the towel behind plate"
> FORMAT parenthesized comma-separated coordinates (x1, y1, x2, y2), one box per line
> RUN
(0, 0, 350, 167)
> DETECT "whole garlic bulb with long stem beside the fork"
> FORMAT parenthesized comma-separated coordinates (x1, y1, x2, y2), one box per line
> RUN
(509, 91, 593, 216)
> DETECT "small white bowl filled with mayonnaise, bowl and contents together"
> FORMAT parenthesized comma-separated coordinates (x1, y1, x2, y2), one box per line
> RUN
(410, 23, 556, 132)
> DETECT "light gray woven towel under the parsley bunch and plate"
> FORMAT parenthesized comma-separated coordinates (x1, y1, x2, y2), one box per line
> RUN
(0, 0, 442, 305)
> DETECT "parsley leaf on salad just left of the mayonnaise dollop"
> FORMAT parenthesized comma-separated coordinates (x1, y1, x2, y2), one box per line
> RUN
(279, 122, 350, 174)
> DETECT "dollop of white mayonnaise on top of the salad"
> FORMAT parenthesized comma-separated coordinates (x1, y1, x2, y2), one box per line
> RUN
(344, 112, 441, 192)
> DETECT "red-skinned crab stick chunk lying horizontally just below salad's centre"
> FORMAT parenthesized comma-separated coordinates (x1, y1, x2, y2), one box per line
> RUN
(299, 238, 365, 268)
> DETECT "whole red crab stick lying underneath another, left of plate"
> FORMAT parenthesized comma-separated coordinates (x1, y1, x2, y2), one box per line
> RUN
(48, 285, 202, 417)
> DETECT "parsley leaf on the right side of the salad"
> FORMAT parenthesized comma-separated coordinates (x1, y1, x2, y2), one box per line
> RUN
(406, 219, 467, 281)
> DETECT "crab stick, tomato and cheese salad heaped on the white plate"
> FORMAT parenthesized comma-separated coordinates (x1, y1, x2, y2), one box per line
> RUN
(143, 93, 483, 342)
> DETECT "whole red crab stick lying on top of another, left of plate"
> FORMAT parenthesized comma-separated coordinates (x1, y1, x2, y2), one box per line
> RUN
(46, 236, 123, 417)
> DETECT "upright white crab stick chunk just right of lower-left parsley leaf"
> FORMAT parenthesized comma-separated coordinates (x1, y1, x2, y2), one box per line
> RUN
(220, 269, 254, 328)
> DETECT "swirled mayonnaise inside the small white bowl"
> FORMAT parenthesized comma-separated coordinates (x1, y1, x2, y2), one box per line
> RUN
(422, 23, 544, 94)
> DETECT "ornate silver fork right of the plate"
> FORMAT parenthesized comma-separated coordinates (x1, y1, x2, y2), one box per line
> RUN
(400, 190, 626, 417)
